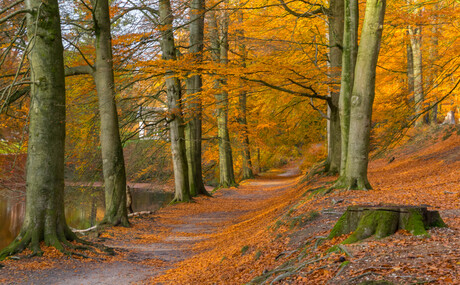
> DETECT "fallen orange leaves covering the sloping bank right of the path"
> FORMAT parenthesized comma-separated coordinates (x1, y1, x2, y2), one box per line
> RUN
(151, 132, 460, 284)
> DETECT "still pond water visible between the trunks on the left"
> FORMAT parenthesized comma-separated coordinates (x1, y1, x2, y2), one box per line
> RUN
(0, 187, 174, 249)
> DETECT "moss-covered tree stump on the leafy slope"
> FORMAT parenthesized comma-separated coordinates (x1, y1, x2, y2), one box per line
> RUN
(328, 206, 446, 244)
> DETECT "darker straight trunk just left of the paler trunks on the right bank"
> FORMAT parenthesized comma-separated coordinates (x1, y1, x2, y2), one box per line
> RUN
(326, 0, 344, 174)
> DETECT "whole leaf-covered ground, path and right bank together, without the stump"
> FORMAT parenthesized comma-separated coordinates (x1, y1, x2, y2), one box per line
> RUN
(0, 127, 460, 285)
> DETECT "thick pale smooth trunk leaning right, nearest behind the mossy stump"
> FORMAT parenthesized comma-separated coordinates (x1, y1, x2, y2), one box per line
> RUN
(344, 0, 386, 190)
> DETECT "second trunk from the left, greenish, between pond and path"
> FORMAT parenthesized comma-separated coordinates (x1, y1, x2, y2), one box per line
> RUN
(92, 0, 129, 226)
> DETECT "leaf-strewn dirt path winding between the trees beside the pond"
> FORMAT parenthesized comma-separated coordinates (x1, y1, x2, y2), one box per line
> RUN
(0, 161, 300, 285)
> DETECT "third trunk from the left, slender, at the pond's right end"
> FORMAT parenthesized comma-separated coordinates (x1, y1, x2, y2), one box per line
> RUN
(160, 0, 191, 202)
